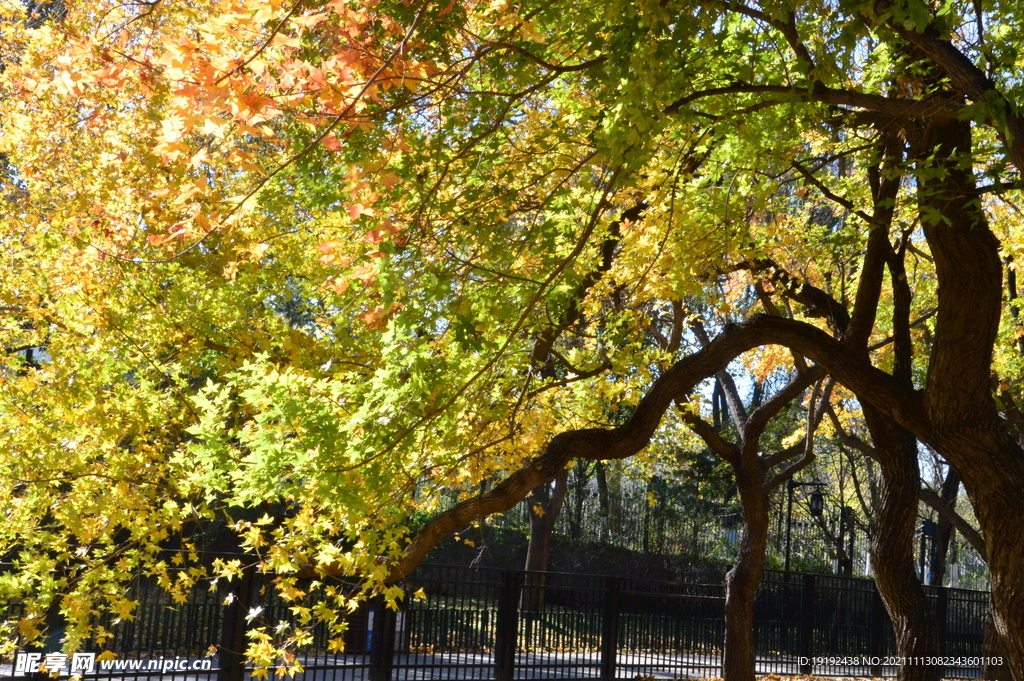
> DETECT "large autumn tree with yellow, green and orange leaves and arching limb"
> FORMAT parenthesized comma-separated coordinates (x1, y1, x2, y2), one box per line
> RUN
(8, 0, 1024, 680)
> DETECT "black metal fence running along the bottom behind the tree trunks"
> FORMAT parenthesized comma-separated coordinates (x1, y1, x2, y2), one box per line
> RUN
(0, 565, 988, 681)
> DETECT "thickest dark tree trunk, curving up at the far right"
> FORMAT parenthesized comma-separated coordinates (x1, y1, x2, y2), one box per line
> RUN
(915, 116, 1024, 678)
